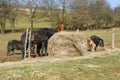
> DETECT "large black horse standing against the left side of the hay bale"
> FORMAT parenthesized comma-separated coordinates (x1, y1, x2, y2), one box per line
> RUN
(21, 28, 57, 56)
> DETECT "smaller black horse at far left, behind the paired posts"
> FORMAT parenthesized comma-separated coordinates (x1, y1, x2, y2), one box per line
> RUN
(7, 40, 35, 59)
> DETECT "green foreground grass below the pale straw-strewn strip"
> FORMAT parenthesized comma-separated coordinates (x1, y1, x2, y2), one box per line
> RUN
(0, 54, 120, 80)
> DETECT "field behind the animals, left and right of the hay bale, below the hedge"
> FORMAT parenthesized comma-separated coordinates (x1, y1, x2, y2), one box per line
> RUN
(0, 28, 120, 62)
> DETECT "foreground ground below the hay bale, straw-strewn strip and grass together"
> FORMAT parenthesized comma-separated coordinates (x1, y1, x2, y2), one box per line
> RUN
(0, 43, 120, 80)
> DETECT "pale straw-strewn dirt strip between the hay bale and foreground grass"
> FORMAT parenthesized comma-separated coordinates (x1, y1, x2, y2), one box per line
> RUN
(0, 48, 120, 63)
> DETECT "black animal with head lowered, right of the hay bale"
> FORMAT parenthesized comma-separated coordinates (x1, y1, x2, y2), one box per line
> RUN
(90, 35, 104, 51)
